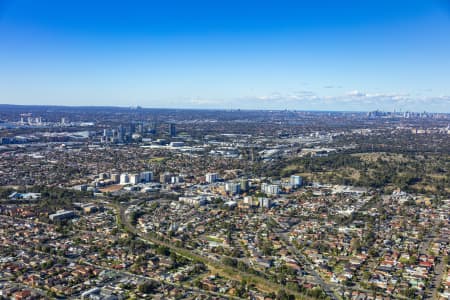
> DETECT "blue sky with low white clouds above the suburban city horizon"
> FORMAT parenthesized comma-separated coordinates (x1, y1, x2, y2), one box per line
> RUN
(0, 0, 450, 112)
